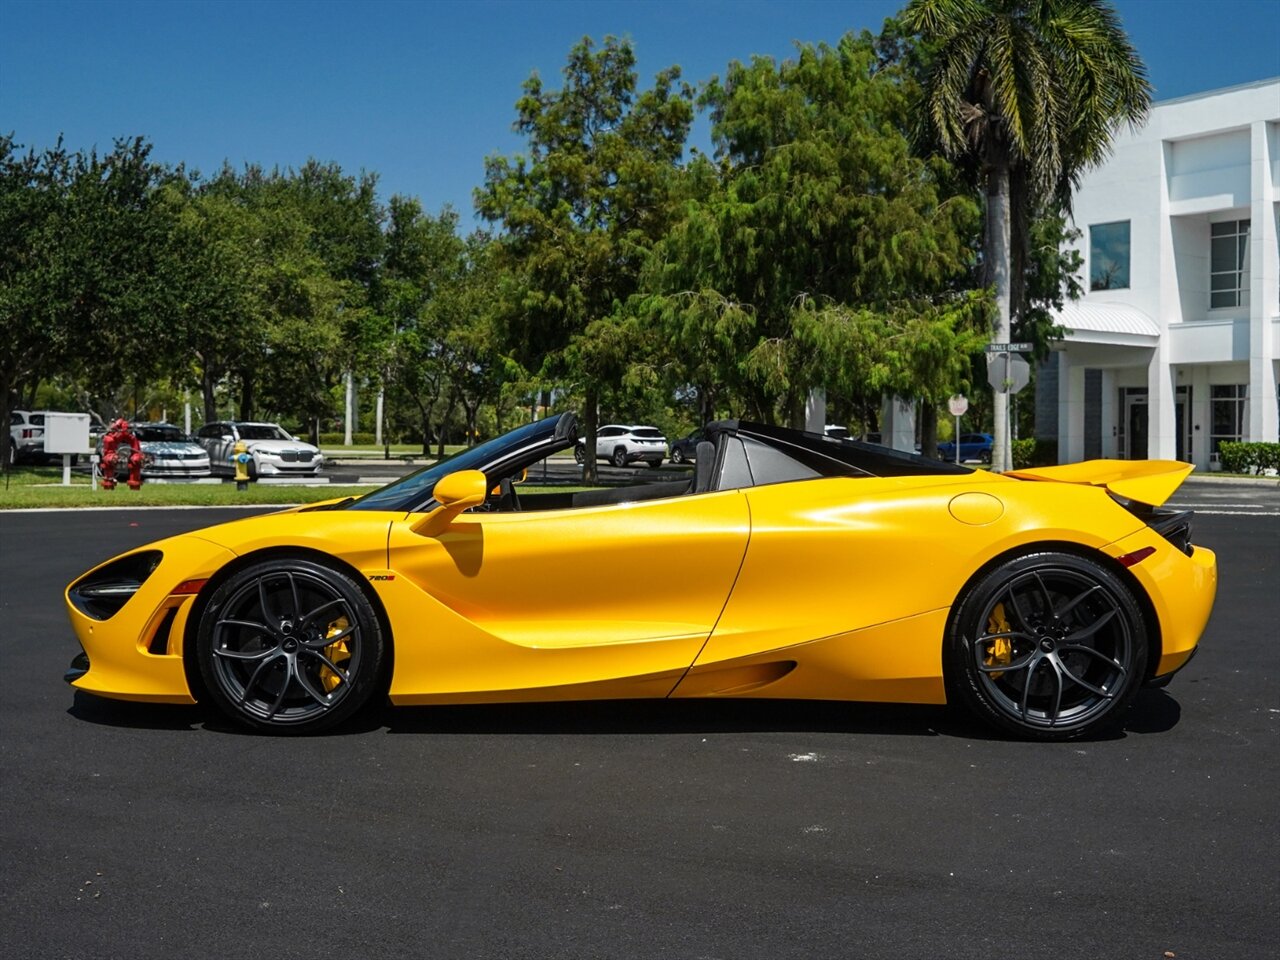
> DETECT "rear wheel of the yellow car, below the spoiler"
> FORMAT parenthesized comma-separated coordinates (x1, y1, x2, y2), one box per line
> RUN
(943, 553, 1148, 740)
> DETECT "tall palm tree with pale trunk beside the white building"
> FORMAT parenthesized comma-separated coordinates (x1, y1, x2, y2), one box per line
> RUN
(902, 0, 1151, 470)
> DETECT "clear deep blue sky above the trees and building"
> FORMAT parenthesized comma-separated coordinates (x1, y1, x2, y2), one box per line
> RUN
(0, 0, 1280, 223)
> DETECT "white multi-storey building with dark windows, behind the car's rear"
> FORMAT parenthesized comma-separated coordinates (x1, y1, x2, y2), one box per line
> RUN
(1037, 78, 1280, 470)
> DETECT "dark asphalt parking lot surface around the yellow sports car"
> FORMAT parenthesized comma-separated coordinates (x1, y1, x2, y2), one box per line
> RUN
(0, 484, 1280, 960)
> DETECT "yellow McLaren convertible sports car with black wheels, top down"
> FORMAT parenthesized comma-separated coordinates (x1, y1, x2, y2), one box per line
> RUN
(67, 413, 1217, 740)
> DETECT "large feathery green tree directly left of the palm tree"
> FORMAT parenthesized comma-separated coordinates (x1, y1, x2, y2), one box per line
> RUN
(649, 33, 980, 425)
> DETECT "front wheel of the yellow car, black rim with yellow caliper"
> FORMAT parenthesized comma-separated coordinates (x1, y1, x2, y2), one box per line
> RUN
(196, 558, 387, 733)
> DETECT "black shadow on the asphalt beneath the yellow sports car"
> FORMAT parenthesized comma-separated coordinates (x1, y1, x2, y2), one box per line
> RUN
(68, 690, 1181, 741)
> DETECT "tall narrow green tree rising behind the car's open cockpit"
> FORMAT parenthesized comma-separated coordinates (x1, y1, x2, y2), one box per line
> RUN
(476, 37, 692, 480)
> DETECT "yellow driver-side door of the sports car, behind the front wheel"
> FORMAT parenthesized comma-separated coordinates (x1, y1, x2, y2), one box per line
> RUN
(388, 490, 750, 703)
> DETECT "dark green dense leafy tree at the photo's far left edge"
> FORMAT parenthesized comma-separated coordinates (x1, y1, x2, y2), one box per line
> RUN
(0, 137, 173, 458)
